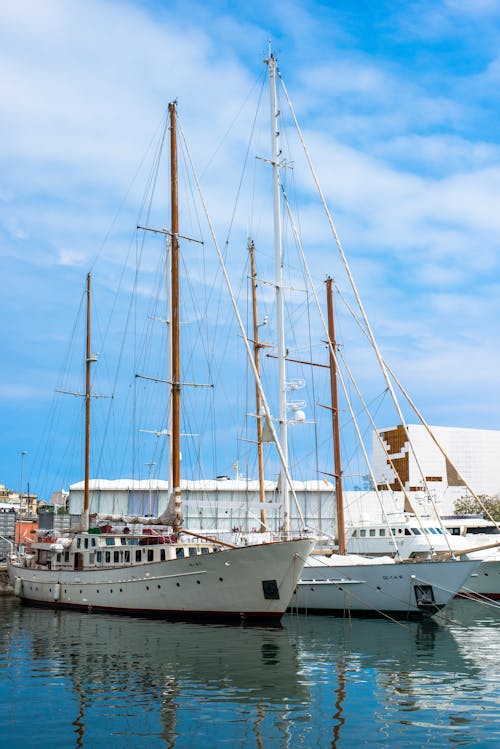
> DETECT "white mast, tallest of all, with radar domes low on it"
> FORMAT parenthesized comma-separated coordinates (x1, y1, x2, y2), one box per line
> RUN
(266, 52, 290, 532)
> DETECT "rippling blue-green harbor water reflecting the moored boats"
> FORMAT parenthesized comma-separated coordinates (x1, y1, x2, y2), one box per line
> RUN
(0, 597, 500, 749)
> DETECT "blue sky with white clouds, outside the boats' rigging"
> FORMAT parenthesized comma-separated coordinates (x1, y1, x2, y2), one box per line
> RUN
(0, 0, 500, 500)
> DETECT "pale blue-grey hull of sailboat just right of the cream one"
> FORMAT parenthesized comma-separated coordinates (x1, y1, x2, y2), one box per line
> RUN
(292, 557, 479, 618)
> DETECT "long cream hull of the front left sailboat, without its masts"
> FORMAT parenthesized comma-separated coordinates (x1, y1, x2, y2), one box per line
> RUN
(8, 540, 312, 619)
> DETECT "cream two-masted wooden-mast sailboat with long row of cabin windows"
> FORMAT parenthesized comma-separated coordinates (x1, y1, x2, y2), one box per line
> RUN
(8, 103, 313, 621)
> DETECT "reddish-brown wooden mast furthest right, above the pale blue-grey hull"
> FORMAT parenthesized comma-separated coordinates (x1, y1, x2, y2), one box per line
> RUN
(326, 278, 347, 554)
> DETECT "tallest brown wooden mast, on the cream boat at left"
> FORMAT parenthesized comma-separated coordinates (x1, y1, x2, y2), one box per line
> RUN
(168, 102, 182, 531)
